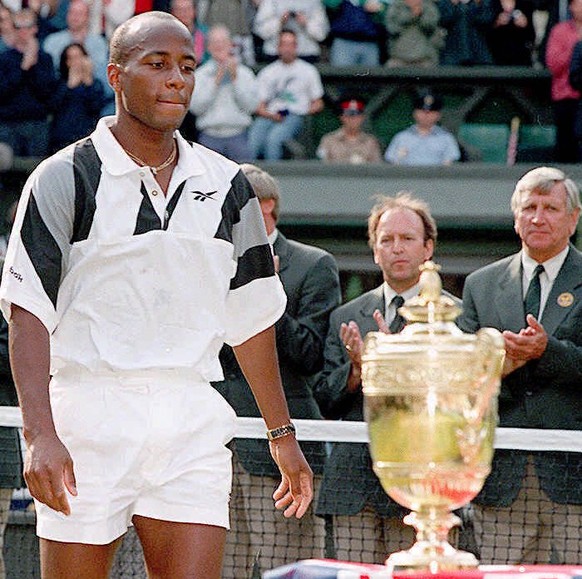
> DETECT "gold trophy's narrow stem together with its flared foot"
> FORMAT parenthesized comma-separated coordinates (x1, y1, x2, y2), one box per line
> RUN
(386, 507, 479, 573)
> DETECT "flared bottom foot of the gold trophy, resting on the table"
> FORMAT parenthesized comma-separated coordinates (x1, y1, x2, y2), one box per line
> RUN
(386, 541, 479, 574)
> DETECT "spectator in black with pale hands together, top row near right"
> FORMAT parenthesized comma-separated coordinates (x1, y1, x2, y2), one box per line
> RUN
(488, 0, 536, 66)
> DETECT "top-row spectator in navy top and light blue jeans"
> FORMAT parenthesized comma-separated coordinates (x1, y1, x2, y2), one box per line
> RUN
(323, 0, 388, 66)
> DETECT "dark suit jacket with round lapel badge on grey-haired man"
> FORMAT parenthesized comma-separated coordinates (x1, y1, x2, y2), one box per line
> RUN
(458, 246, 582, 506)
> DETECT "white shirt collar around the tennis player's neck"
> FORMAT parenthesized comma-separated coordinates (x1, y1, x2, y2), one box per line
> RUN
(91, 116, 204, 180)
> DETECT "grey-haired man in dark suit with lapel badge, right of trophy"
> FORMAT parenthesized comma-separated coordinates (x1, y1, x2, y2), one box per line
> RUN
(458, 167, 582, 564)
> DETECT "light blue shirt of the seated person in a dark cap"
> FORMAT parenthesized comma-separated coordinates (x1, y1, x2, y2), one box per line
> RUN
(384, 125, 461, 165)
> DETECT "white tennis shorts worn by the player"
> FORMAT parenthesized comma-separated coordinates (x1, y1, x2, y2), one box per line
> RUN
(35, 370, 236, 545)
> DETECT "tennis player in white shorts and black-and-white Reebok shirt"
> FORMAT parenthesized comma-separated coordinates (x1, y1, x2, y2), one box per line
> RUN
(0, 12, 313, 579)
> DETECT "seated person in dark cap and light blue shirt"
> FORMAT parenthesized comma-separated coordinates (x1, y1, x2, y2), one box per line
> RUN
(384, 92, 461, 165)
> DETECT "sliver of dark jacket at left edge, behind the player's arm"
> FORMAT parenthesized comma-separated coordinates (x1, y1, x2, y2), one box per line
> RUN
(0, 315, 24, 489)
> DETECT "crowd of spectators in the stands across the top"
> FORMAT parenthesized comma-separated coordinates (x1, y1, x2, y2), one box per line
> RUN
(0, 0, 582, 164)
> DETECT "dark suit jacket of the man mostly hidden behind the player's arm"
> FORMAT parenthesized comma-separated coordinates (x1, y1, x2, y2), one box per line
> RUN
(214, 232, 341, 476)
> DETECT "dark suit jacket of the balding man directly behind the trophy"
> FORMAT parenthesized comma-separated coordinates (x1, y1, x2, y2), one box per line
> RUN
(314, 286, 459, 517)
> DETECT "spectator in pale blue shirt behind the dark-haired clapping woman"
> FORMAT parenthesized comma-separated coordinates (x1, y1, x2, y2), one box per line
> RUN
(43, 0, 113, 114)
